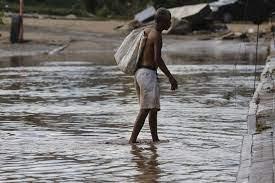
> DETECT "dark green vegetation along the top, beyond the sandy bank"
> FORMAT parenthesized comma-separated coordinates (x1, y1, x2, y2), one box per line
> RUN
(4, 0, 214, 19)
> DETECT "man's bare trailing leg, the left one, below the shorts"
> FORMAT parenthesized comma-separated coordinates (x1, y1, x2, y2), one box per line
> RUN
(129, 109, 150, 143)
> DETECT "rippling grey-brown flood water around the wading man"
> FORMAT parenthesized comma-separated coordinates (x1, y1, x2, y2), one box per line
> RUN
(0, 44, 268, 183)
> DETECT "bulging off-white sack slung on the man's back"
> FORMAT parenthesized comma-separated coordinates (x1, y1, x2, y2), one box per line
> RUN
(114, 29, 147, 75)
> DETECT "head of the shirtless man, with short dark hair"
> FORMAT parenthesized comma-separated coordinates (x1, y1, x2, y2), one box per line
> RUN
(155, 8, 171, 30)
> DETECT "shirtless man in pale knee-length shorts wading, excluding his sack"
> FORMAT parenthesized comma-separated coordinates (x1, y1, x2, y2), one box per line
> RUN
(129, 8, 178, 143)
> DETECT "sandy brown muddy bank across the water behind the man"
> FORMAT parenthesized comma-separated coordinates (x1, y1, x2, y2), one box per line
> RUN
(0, 18, 270, 64)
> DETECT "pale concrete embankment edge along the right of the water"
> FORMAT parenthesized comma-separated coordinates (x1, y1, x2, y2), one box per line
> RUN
(237, 41, 275, 183)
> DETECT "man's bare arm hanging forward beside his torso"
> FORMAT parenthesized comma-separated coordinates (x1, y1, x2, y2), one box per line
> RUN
(154, 34, 178, 90)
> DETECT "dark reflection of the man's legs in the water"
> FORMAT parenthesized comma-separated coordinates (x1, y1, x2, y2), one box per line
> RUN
(131, 143, 161, 183)
